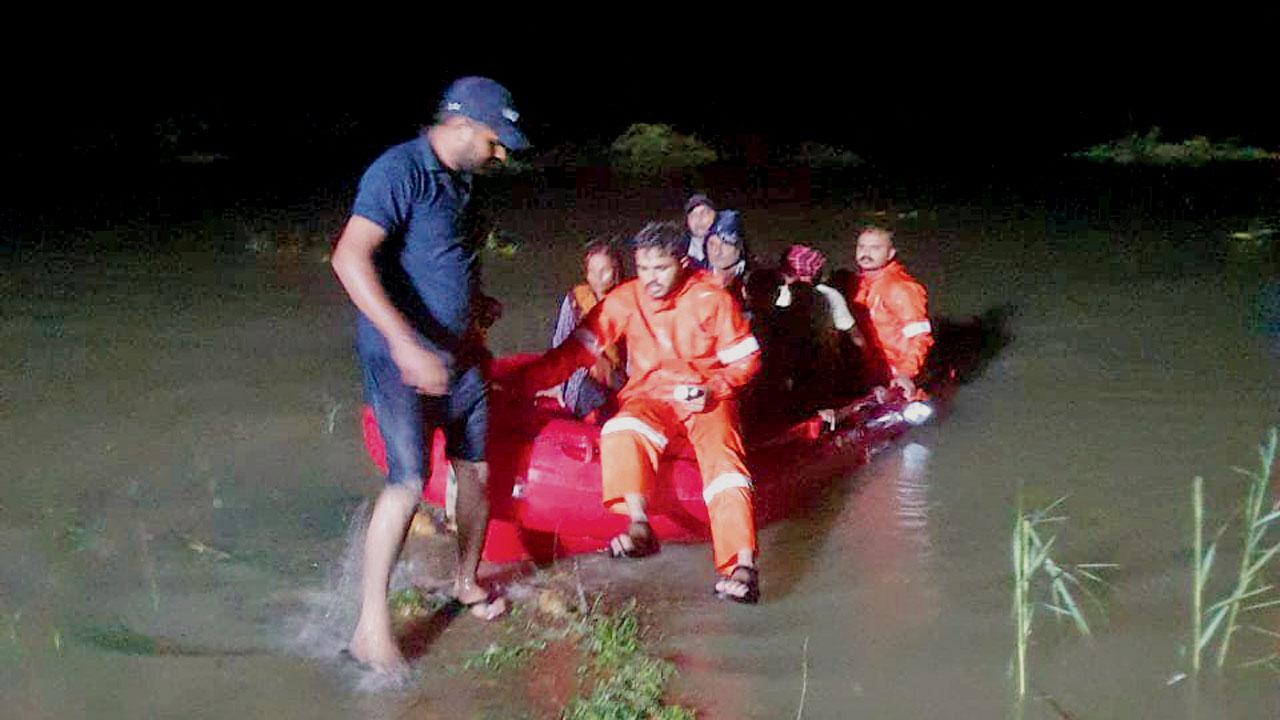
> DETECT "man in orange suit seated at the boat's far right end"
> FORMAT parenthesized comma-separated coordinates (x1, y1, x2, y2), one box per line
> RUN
(849, 227, 933, 398)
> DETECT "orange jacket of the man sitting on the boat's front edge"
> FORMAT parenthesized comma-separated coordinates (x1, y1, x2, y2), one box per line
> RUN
(520, 273, 760, 402)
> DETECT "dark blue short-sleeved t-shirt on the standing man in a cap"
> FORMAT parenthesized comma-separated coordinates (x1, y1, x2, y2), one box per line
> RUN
(352, 136, 476, 372)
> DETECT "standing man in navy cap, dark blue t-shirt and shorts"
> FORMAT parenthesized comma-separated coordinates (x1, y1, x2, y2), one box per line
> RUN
(333, 77, 529, 674)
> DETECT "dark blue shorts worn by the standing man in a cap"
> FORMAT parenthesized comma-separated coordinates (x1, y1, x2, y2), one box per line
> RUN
(357, 348, 489, 484)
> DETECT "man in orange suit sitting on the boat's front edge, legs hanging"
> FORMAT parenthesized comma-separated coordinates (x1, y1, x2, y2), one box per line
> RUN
(512, 223, 760, 603)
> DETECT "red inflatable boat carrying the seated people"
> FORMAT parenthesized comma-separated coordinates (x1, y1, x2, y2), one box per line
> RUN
(362, 355, 932, 562)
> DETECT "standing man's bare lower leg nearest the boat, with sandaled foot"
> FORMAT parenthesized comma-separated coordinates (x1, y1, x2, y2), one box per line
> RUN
(451, 460, 507, 619)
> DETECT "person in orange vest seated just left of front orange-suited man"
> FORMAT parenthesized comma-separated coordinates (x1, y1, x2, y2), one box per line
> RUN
(543, 238, 627, 423)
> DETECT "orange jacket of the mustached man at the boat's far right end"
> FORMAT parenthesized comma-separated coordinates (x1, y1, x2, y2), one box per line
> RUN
(850, 260, 933, 378)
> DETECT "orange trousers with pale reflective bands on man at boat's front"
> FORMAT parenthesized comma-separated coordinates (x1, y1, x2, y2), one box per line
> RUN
(600, 398, 756, 575)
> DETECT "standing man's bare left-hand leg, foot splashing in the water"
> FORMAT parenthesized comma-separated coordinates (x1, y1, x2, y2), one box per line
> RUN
(347, 480, 422, 674)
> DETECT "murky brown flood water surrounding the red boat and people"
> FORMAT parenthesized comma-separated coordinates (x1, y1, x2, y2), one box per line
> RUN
(0, 165, 1280, 719)
